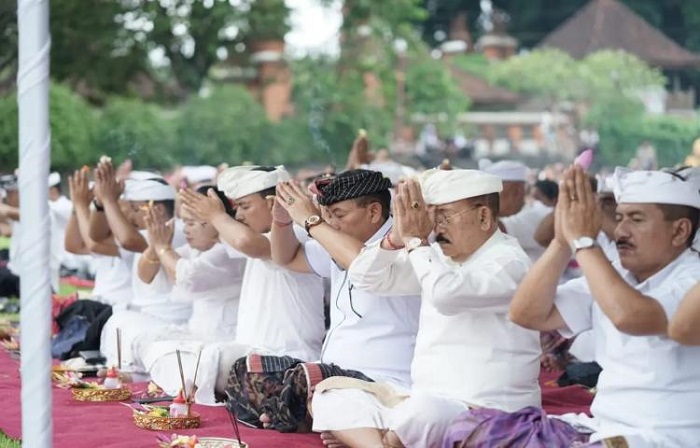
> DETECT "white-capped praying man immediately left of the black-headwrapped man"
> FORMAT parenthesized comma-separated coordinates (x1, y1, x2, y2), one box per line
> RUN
(180, 165, 325, 362)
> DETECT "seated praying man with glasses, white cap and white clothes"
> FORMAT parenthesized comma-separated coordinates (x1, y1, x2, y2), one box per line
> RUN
(313, 170, 541, 448)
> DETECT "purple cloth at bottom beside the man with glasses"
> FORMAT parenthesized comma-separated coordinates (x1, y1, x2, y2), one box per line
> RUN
(442, 406, 588, 448)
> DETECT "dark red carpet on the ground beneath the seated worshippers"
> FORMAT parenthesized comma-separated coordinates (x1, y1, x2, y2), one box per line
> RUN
(0, 350, 593, 448)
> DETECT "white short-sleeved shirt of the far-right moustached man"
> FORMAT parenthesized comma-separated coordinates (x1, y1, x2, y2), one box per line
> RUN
(555, 250, 700, 447)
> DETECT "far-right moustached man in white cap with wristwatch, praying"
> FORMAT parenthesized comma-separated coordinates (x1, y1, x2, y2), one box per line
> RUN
(510, 167, 700, 447)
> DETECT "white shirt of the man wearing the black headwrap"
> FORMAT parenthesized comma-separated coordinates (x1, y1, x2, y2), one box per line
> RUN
(304, 219, 420, 387)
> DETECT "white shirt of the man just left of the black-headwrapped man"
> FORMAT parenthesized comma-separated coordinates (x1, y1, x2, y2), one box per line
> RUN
(231, 226, 325, 361)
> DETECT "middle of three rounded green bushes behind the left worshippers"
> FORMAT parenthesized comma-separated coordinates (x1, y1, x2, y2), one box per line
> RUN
(92, 98, 175, 168)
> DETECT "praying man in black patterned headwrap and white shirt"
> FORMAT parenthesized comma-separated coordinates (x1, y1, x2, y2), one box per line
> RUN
(241, 169, 420, 429)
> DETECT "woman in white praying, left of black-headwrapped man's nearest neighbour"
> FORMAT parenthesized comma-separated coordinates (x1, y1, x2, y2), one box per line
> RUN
(135, 187, 246, 404)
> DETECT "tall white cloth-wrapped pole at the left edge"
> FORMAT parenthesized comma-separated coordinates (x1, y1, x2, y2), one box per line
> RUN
(17, 0, 53, 448)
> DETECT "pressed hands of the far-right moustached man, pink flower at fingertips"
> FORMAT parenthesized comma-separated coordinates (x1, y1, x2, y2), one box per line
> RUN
(554, 165, 602, 247)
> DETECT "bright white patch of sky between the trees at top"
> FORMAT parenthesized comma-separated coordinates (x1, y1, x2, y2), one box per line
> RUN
(285, 0, 342, 56)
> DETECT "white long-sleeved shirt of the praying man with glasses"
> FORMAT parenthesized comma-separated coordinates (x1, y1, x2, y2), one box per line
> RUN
(350, 231, 541, 411)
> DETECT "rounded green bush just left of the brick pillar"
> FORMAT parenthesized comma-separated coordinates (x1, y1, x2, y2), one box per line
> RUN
(173, 86, 271, 165)
